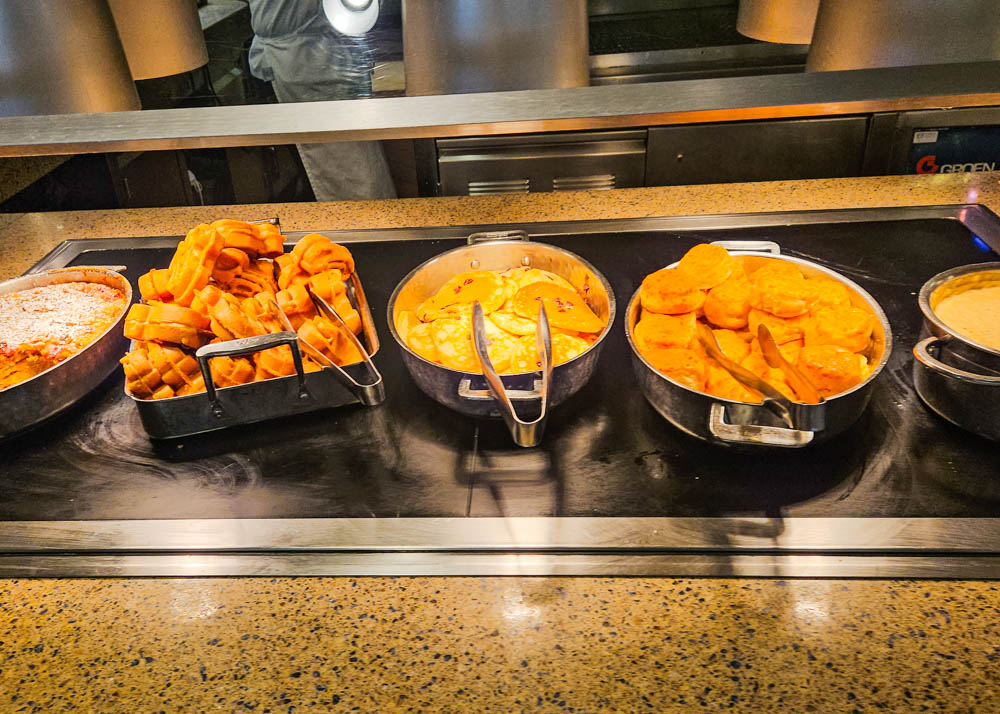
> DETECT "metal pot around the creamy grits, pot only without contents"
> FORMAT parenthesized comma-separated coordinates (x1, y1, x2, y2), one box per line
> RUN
(913, 263, 1000, 440)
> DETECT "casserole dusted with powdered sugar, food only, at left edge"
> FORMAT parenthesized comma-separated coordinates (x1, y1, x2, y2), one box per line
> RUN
(0, 282, 125, 389)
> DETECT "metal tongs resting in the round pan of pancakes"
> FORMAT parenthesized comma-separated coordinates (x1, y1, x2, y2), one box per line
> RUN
(472, 300, 552, 447)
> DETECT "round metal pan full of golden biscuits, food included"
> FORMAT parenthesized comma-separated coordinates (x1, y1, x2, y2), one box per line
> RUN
(625, 241, 892, 448)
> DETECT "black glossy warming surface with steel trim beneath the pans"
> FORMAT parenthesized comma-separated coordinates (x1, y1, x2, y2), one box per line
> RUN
(0, 206, 1000, 577)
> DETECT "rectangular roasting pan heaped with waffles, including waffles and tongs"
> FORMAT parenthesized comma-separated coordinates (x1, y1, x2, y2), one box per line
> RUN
(121, 219, 385, 439)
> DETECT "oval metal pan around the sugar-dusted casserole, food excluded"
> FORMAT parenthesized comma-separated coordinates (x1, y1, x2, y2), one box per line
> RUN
(0, 266, 132, 439)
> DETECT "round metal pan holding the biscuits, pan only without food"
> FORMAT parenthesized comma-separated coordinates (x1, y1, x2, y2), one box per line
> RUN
(625, 240, 892, 448)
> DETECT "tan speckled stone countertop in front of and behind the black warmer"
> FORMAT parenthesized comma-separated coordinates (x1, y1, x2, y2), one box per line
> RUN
(0, 174, 1000, 712)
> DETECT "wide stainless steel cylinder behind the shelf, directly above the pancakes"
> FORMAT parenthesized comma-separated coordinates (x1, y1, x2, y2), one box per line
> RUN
(403, 0, 590, 95)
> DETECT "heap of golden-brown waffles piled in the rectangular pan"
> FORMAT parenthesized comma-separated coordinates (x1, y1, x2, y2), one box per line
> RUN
(121, 219, 362, 399)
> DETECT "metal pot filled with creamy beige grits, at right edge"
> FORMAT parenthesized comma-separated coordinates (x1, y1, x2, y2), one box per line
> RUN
(913, 262, 1000, 440)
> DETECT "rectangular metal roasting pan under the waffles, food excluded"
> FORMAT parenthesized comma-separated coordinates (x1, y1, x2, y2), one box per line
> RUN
(125, 273, 385, 439)
